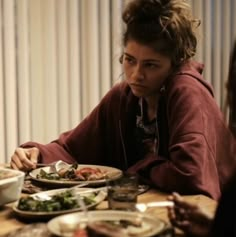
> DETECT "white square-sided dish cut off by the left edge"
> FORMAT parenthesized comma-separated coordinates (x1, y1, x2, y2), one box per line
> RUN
(0, 168, 25, 206)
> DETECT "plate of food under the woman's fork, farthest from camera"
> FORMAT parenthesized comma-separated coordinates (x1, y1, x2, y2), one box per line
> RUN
(29, 161, 122, 187)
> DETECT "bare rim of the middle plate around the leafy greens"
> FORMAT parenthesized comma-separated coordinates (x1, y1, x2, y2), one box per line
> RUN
(13, 188, 107, 219)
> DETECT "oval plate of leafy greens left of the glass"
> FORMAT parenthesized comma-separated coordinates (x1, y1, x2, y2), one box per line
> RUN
(13, 187, 107, 220)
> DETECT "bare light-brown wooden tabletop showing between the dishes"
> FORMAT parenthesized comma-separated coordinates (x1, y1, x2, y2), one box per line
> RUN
(0, 189, 217, 236)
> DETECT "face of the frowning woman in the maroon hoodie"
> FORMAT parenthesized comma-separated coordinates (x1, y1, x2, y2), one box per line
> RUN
(123, 40, 172, 98)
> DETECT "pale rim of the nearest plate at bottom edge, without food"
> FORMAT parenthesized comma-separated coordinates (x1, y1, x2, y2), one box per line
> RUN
(47, 210, 167, 237)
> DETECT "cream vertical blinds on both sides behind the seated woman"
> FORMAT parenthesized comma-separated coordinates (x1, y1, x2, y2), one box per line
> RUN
(0, 0, 236, 163)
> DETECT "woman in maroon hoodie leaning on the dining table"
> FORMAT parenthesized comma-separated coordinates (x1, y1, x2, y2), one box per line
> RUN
(11, 0, 235, 199)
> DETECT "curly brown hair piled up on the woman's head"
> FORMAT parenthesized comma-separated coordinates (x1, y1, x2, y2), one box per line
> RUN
(122, 0, 200, 66)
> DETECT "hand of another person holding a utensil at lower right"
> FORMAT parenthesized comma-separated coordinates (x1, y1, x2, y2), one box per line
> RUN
(168, 193, 213, 237)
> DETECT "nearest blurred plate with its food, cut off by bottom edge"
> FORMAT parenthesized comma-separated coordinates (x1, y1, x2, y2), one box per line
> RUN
(48, 210, 170, 237)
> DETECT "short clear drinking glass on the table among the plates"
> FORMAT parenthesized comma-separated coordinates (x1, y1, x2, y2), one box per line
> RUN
(108, 174, 138, 211)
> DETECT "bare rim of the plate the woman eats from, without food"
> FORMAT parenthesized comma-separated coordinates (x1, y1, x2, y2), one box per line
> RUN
(29, 165, 122, 187)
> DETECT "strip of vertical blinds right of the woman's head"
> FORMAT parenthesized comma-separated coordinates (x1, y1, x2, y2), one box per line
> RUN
(191, 0, 236, 109)
